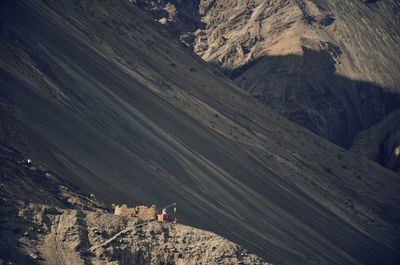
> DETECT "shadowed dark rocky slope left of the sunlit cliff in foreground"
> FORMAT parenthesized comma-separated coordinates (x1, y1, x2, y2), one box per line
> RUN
(0, 142, 110, 264)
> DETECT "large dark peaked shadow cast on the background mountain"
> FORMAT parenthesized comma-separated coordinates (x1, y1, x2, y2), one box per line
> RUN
(227, 46, 400, 148)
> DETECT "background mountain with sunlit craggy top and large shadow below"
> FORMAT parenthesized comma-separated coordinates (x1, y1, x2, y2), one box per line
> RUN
(137, 0, 400, 147)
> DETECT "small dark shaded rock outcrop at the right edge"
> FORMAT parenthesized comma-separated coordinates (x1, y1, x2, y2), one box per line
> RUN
(351, 110, 400, 173)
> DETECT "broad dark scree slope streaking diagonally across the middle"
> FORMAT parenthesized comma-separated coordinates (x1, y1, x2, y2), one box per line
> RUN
(0, 0, 400, 265)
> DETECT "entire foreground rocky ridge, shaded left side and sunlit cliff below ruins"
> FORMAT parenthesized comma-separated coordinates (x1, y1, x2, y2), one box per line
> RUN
(0, 144, 268, 265)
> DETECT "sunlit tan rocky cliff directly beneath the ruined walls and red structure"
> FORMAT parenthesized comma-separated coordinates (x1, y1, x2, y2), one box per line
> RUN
(39, 210, 267, 265)
